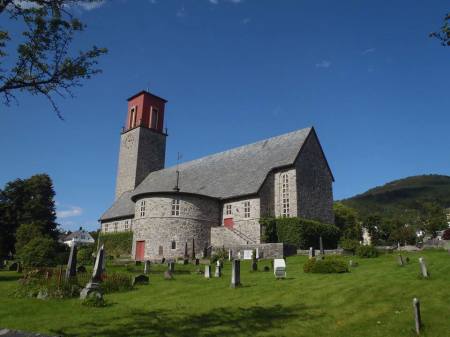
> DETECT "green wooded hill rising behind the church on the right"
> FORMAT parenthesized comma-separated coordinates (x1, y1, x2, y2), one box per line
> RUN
(341, 174, 450, 217)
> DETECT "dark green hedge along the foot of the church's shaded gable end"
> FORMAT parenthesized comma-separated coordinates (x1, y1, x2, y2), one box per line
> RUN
(260, 218, 340, 249)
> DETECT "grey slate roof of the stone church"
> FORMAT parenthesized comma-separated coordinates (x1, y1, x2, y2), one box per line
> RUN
(100, 128, 313, 220)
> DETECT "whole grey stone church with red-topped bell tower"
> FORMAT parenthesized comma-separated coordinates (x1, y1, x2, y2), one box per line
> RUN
(100, 91, 334, 260)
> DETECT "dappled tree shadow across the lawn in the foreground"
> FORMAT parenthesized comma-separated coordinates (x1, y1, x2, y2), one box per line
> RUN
(52, 305, 320, 337)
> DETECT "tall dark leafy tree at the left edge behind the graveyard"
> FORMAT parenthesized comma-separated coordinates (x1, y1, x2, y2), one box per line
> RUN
(0, 174, 58, 256)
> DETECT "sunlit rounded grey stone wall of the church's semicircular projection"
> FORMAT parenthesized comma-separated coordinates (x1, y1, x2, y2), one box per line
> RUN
(132, 194, 220, 260)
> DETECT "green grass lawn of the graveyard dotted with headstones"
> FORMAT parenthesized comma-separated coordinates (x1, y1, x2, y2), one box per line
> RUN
(0, 250, 450, 337)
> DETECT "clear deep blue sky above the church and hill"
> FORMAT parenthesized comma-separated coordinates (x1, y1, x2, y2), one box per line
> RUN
(0, 0, 450, 229)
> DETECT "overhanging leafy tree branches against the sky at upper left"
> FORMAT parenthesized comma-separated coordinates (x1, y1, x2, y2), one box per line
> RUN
(0, 0, 107, 119)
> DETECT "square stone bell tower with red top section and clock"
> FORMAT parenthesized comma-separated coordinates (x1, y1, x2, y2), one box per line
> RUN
(116, 91, 167, 199)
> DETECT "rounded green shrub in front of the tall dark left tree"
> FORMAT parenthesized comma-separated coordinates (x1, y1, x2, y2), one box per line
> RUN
(17, 237, 58, 267)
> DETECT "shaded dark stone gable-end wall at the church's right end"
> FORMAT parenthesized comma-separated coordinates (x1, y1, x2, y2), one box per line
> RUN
(295, 134, 334, 223)
